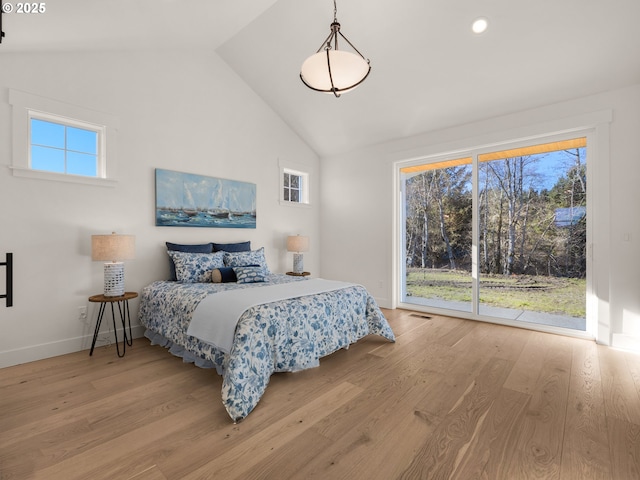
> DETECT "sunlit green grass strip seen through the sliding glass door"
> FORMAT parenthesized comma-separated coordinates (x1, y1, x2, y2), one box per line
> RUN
(407, 268, 586, 318)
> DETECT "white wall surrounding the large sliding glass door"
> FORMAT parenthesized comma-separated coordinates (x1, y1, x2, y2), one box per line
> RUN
(321, 85, 640, 351)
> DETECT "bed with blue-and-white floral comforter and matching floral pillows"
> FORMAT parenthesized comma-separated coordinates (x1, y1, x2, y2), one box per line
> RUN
(139, 244, 395, 422)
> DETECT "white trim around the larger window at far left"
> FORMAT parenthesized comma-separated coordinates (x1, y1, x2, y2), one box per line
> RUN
(9, 89, 118, 187)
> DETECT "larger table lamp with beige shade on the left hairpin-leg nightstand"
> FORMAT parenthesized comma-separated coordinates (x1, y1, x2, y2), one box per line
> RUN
(91, 232, 136, 297)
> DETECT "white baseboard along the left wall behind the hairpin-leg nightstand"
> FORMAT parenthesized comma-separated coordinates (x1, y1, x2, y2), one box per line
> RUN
(0, 325, 145, 368)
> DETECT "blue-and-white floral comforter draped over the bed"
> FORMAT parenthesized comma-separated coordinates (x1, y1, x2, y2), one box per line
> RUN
(139, 274, 395, 422)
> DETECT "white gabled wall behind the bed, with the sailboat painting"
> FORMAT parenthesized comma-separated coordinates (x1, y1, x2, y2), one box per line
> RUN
(0, 50, 319, 367)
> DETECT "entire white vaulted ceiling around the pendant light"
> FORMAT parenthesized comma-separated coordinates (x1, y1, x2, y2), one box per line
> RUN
(0, 0, 640, 156)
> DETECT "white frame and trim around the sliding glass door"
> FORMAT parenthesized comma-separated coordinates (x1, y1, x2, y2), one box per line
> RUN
(392, 110, 612, 345)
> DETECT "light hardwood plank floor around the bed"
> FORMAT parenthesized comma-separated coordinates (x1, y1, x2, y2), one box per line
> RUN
(0, 310, 640, 480)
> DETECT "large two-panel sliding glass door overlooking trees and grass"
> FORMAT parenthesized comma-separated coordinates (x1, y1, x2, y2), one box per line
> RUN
(400, 137, 588, 331)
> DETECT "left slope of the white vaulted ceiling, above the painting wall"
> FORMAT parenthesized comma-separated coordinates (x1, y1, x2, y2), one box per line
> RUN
(0, 0, 276, 54)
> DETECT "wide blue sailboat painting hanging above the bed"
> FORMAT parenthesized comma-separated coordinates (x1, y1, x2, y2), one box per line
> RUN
(156, 168, 256, 228)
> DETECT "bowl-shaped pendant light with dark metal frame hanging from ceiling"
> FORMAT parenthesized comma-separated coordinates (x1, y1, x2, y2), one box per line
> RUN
(300, 0, 371, 97)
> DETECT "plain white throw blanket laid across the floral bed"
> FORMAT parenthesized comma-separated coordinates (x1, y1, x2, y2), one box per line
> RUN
(187, 278, 354, 353)
